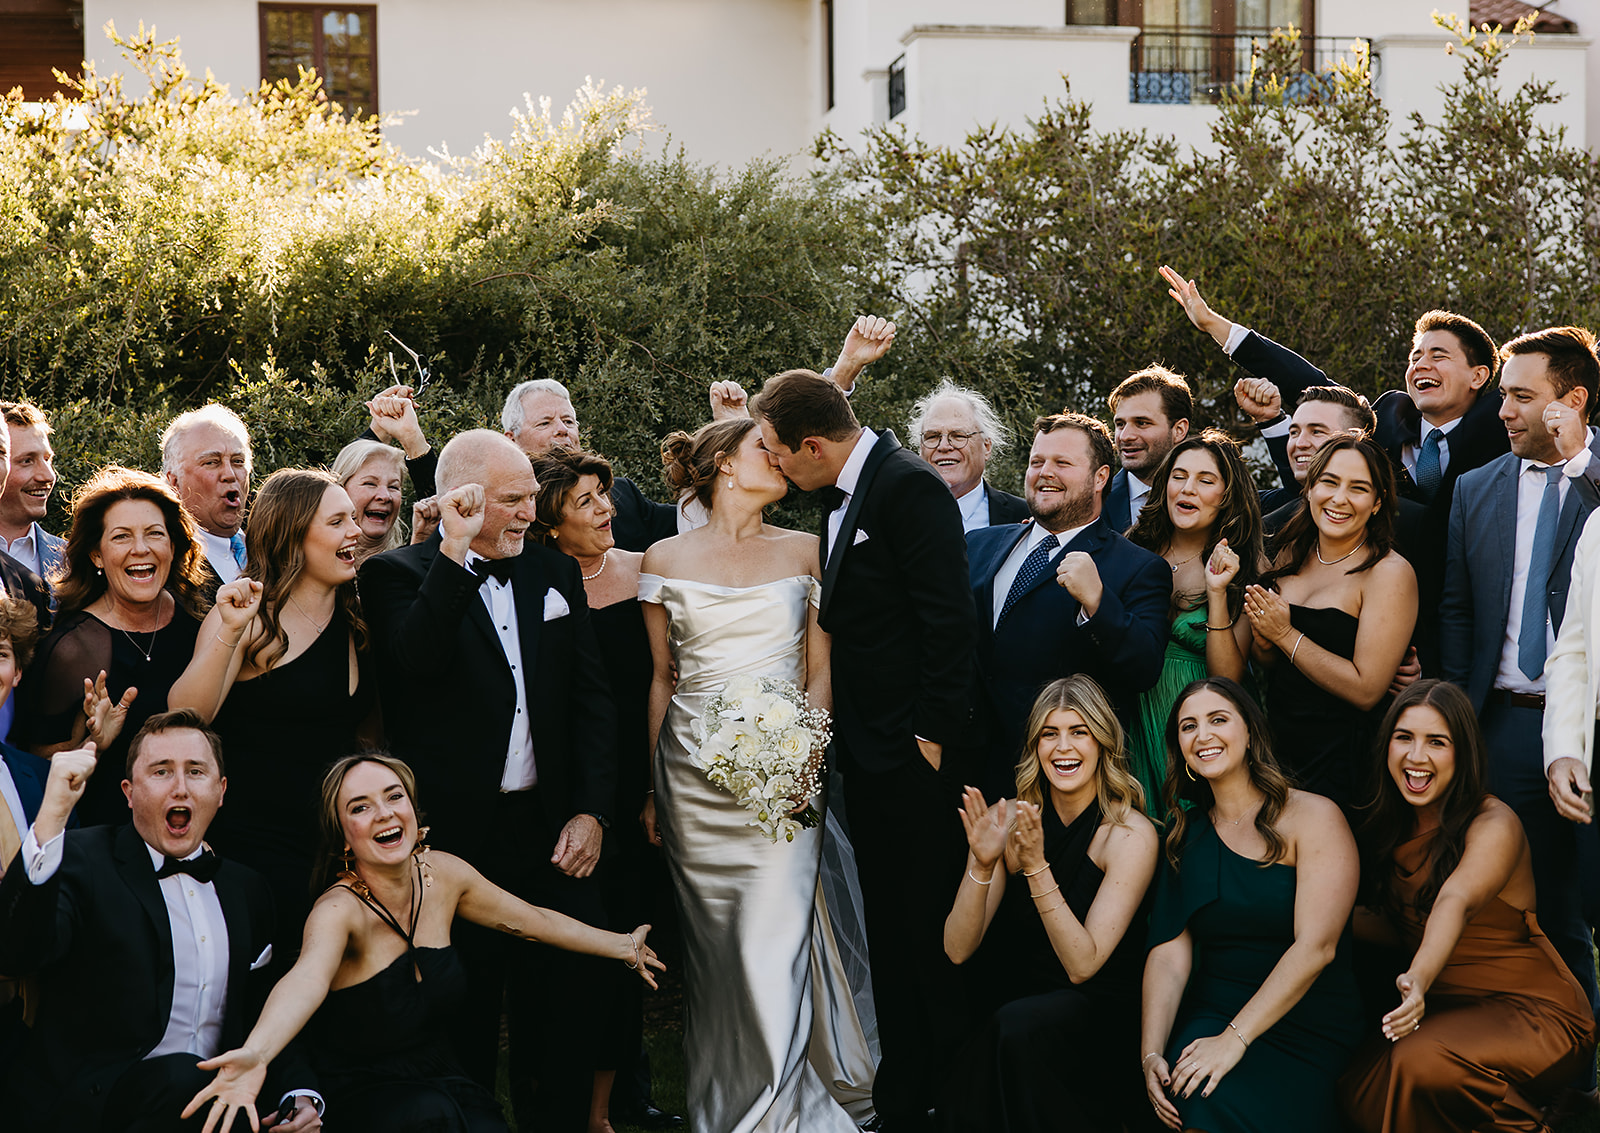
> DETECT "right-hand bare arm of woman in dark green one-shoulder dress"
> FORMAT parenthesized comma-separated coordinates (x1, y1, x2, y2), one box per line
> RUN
(1171, 792, 1360, 1098)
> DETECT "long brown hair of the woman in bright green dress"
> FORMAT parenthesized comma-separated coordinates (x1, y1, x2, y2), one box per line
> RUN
(1128, 429, 1261, 618)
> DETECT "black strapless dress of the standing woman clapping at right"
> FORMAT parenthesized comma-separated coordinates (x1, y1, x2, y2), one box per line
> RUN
(1266, 605, 1373, 815)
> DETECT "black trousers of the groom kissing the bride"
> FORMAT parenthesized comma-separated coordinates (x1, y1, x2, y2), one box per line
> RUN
(840, 741, 966, 1131)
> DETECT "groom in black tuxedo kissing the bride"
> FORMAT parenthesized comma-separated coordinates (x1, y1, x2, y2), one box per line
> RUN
(750, 348, 978, 1133)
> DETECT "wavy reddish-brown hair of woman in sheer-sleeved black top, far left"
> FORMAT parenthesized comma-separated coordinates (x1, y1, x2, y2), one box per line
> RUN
(51, 464, 211, 619)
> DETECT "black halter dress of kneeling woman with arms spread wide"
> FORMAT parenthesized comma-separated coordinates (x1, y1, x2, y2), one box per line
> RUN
(306, 946, 506, 1133)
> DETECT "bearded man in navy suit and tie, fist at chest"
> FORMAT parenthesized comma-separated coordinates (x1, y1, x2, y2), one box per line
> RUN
(966, 413, 1173, 799)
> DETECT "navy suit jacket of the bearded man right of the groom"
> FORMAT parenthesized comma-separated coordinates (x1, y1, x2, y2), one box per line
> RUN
(966, 520, 1173, 799)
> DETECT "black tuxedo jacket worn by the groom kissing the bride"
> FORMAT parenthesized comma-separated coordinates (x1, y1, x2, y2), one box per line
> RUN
(818, 432, 978, 771)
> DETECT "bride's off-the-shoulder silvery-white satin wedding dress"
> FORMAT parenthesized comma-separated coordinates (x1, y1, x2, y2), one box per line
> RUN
(638, 575, 874, 1133)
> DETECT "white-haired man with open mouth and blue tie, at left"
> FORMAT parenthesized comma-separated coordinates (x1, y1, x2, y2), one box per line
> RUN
(162, 402, 251, 594)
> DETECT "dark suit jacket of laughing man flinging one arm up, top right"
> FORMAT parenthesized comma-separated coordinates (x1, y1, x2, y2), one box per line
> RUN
(1234, 331, 1510, 677)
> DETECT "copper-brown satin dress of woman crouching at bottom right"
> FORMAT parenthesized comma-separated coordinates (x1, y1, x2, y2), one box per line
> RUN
(1339, 831, 1594, 1133)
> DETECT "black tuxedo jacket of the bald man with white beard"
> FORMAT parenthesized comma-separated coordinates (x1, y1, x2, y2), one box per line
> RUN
(360, 533, 614, 866)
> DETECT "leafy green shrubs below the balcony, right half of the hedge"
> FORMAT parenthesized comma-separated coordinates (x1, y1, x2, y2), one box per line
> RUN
(819, 19, 1600, 483)
